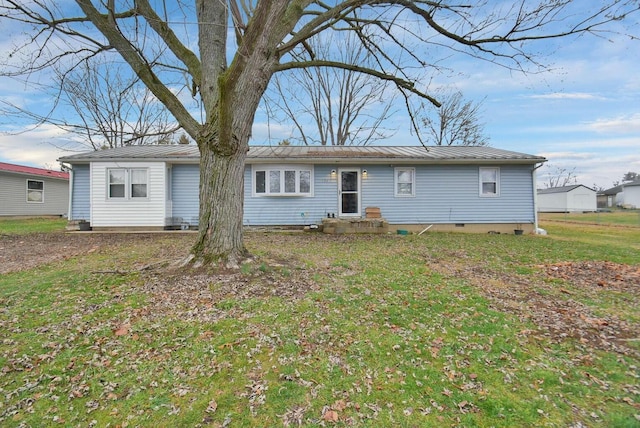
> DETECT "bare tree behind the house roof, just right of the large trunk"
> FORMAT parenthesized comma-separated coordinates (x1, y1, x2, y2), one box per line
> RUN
(265, 33, 394, 146)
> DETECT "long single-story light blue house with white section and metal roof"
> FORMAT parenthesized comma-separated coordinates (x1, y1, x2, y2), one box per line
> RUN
(59, 145, 546, 233)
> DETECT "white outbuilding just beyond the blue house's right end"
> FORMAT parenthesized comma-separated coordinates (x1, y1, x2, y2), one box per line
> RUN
(538, 184, 598, 213)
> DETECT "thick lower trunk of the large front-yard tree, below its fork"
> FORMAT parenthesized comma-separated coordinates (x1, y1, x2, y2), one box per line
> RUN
(191, 143, 248, 268)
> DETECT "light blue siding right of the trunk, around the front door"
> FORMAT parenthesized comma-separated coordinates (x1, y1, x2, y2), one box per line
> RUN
(244, 165, 534, 225)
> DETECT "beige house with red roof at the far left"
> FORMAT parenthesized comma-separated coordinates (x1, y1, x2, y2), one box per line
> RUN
(0, 162, 69, 216)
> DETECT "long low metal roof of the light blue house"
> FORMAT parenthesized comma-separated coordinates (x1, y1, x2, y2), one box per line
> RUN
(58, 145, 546, 164)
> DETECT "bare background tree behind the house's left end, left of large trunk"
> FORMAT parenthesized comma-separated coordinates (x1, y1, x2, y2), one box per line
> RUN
(3, 58, 180, 150)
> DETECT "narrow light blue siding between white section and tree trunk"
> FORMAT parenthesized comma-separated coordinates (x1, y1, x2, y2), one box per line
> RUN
(171, 165, 200, 222)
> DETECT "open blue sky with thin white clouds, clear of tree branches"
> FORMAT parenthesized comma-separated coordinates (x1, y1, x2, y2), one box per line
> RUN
(0, 2, 640, 188)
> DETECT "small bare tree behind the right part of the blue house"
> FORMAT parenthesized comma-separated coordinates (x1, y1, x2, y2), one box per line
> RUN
(422, 92, 489, 146)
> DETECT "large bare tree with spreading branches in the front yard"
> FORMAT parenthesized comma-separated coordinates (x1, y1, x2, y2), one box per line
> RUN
(0, 0, 639, 265)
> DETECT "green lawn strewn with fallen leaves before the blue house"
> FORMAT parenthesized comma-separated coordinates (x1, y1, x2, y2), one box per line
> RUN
(0, 221, 640, 427)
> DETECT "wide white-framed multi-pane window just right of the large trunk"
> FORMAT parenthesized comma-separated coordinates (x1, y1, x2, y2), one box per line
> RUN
(253, 166, 312, 196)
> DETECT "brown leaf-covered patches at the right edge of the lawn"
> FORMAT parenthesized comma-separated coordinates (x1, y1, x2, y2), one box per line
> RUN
(429, 259, 640, 358)
